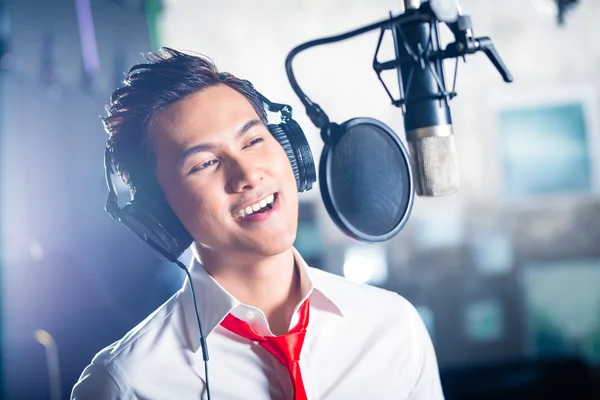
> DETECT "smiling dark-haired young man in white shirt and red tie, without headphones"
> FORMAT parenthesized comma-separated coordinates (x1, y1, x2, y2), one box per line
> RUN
(71, 49, 443, 400)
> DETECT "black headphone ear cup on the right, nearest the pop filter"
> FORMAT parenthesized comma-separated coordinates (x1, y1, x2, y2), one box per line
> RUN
(267, 119, 317, 193)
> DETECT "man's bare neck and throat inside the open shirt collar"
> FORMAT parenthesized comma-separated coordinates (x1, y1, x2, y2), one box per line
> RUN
(196, 248, 302, 335)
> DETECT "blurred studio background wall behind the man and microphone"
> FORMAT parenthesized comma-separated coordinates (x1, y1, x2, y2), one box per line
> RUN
(0, 0, 600, 399)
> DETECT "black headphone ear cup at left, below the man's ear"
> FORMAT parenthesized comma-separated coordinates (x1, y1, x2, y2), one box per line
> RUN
(119, 199, 193, 261)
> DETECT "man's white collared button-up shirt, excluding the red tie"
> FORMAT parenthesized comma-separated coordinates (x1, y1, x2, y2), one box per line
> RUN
(71, 251, 443, 400)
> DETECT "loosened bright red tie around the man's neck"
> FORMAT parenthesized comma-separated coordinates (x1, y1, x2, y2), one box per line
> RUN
(221, 299, 309, 400)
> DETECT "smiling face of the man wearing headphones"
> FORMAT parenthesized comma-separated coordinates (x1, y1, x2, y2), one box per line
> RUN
(150, 85, 298, 256)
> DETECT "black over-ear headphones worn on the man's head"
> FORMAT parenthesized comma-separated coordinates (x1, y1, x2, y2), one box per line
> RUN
(104, 81, 316, 262)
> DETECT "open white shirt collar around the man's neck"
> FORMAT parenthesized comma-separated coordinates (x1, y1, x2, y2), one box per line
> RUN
(181, 248, 343, 352)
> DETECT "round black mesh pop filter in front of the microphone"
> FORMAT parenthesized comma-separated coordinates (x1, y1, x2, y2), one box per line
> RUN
(319, 118, 414, 242)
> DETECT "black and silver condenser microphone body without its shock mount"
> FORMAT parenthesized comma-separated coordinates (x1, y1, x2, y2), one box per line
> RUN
(392, 0, 459, 196)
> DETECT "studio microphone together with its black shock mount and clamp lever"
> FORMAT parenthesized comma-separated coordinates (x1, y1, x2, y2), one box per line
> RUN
(373, 0, 512, 196)
